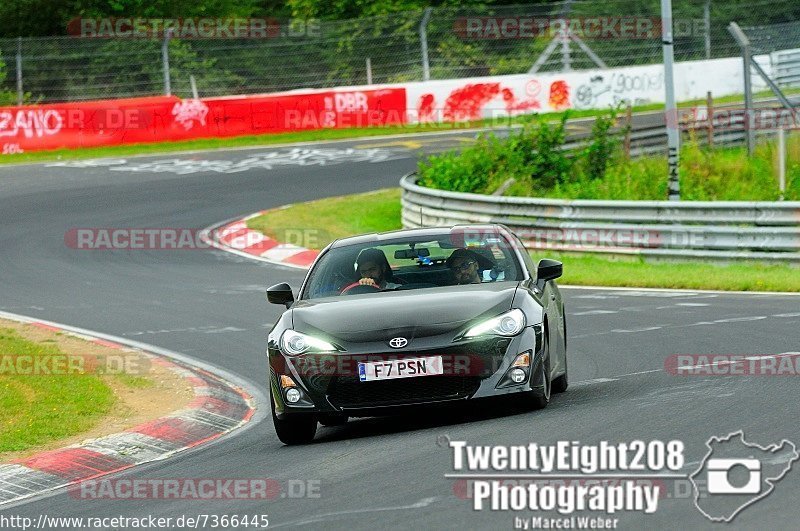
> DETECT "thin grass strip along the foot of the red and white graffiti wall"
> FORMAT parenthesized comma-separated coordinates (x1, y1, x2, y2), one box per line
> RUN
(0, 91, 792, 164)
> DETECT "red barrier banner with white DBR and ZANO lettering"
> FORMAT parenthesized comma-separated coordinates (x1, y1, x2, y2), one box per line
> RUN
(0, 88, 406, 154)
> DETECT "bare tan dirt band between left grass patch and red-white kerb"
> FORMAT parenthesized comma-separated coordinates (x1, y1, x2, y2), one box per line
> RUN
(0, 319, 194, 463)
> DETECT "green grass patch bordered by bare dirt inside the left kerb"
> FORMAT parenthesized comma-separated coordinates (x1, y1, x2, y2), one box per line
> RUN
(0, 328, 115, 452)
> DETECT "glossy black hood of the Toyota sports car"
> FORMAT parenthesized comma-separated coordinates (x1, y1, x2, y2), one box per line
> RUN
(292, 282, 518, 342)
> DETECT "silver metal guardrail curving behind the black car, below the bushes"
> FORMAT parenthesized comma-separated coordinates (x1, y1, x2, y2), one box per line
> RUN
(400, 173, 800, 262)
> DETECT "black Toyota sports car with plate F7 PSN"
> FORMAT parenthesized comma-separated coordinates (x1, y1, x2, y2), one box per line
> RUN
(267, 225, 567, 444)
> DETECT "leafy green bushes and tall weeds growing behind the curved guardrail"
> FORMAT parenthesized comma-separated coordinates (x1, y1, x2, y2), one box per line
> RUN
(418, 109, 800, 201)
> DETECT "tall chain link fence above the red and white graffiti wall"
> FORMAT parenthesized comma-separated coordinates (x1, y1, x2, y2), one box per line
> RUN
(0, 0, 800, 105)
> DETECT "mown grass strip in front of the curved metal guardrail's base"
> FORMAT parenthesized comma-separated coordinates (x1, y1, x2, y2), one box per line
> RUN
(248, 188, 800, 292)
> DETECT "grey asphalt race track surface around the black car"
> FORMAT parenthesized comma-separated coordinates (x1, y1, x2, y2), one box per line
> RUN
(0, 135, 800, 529)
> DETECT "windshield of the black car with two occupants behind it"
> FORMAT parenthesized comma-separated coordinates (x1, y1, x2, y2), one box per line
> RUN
(301, 229, 524, 299)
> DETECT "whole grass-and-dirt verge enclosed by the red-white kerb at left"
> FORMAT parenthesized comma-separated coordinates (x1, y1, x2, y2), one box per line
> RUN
(0, 320, 194, 463)
